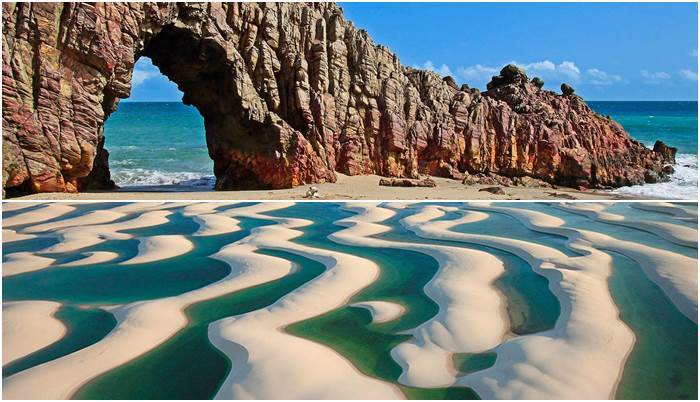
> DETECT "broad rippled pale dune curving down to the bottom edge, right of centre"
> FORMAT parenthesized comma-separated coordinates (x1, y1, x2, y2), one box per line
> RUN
(402, 207, 634, 399)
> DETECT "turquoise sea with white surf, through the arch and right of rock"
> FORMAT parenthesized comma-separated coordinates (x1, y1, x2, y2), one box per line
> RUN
(105, 102, 698, 199)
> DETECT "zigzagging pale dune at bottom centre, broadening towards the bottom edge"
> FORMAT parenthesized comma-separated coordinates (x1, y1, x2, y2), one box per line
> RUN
(209, 206, 401, 399)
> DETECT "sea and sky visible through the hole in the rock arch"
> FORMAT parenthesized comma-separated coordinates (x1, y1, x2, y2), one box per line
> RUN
(104, 56, 214, 191)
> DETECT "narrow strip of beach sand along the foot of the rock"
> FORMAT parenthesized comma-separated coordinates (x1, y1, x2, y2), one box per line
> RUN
(5, 173, 643, 201)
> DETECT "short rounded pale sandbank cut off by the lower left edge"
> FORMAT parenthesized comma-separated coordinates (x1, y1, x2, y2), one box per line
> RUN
(2, 300, 67, 366)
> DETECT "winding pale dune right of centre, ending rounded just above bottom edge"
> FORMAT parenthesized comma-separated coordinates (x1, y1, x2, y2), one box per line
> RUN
(329, 203, 508, 387)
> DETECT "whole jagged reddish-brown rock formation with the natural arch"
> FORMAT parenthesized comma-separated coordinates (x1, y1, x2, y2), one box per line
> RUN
(2, 3, 673, 192)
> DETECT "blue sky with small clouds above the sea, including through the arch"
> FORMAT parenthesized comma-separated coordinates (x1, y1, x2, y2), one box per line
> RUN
(129, 3, 698, 101)
